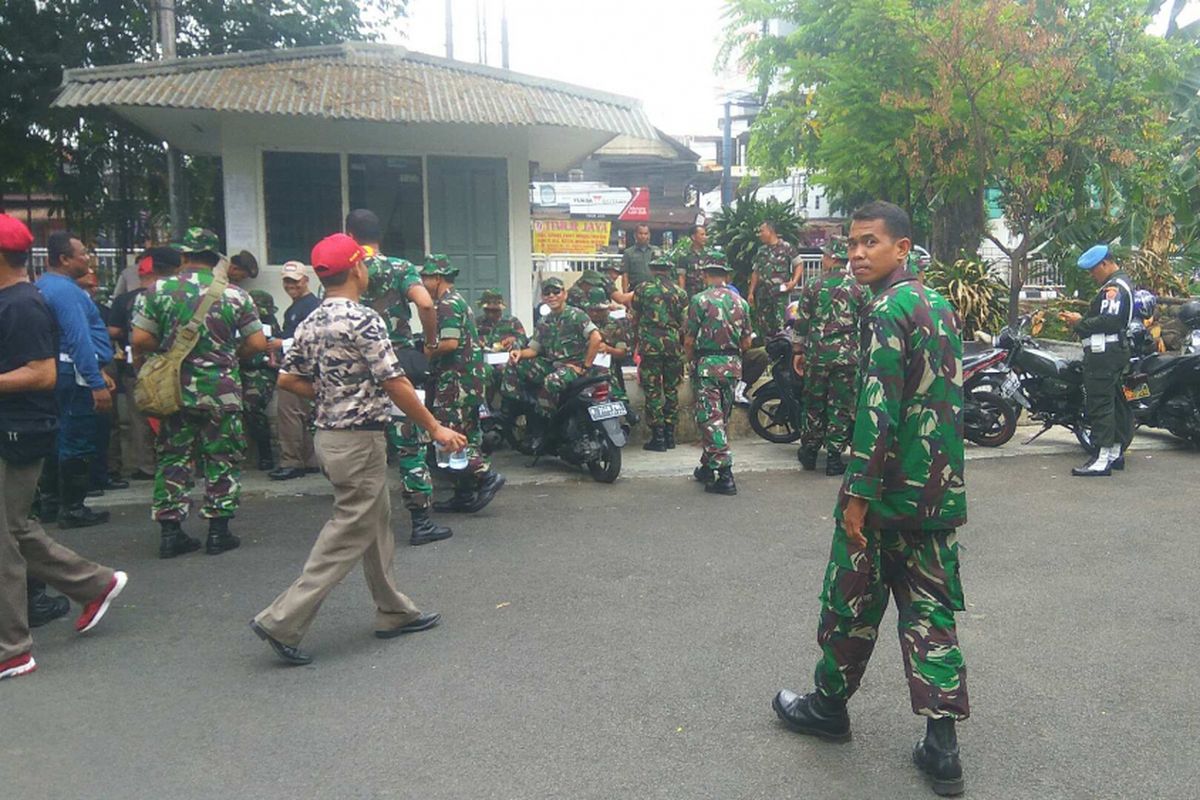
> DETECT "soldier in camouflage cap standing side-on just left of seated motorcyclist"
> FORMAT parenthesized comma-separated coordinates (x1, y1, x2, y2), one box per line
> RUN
(421, 253, 504, 513)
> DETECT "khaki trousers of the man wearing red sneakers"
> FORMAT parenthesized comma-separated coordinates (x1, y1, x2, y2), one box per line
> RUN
(0, 461, 113, 661)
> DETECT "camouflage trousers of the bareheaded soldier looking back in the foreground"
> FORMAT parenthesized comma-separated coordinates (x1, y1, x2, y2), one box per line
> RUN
(815, 522, 970, 720)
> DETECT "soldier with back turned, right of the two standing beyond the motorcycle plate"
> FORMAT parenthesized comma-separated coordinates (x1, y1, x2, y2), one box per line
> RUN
(683, 257, 752, 494)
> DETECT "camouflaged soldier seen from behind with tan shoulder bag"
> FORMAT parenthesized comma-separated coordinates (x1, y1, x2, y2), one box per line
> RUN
(132, 228, 266, 558)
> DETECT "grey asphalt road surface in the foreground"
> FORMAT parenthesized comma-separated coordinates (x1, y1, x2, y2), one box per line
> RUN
(0, 452, 1200, 800)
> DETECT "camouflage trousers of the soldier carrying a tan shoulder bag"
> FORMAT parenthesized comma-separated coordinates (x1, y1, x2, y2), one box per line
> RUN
(150, 409, 246, 522)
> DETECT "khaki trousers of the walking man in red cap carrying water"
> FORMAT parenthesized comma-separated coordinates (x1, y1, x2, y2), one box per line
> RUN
(254, 431, 421, 646)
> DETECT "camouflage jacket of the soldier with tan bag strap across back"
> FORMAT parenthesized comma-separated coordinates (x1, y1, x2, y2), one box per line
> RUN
(133, 270, 263, 411)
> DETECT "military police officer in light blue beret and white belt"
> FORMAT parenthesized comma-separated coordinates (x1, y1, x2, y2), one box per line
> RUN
(1060, 245, 1133, 477)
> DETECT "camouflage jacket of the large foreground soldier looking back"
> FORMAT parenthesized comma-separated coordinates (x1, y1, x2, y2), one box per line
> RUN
(838, 270, 967, 530)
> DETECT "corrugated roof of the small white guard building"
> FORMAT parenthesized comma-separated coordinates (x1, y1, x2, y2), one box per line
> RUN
(54, 42, 658, 139)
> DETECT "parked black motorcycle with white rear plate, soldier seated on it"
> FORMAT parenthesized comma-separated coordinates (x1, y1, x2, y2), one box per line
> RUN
(487, 375, 629, 483)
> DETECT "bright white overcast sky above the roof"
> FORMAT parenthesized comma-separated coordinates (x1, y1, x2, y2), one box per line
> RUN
(389, 0, 1200, 134)
